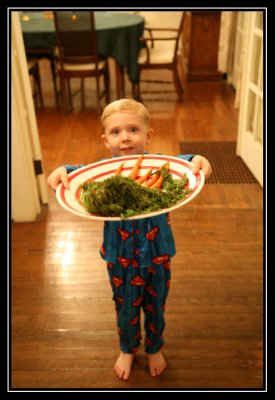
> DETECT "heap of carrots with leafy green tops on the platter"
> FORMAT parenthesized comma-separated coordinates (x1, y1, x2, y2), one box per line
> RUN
(79, 156, 193, 219)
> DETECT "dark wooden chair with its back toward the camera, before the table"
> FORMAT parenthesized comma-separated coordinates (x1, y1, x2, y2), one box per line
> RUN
(54, 11, 109, 113)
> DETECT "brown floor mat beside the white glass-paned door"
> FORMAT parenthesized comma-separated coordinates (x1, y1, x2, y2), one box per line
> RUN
(180, 142, 257, 183)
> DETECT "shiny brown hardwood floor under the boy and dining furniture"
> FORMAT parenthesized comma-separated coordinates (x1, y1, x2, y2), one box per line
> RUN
(11, 62, 264, 391)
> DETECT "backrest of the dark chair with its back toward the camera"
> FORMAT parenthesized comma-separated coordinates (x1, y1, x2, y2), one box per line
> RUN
(54, 11, 98, 64)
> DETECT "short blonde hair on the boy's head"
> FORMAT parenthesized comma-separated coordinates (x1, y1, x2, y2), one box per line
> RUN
(101, 99, 150, 129)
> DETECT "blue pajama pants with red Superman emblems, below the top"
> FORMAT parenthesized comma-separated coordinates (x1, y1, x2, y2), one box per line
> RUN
(107, 257, 171, 354)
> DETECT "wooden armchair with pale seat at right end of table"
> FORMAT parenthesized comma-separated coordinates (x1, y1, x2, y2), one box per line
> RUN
(132, 12, 185, 101)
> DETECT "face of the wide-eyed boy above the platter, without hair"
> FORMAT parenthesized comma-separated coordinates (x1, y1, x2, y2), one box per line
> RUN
(102, 112, 153, 157)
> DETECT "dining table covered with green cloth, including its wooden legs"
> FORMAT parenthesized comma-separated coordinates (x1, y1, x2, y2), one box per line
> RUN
(20, 10, 144, 105)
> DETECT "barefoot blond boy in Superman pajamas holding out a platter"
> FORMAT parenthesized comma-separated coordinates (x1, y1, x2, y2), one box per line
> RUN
(48, 99, 212, 380)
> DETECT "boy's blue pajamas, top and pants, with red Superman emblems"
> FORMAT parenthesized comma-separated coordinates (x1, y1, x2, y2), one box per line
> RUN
(65, 154, 194, 354)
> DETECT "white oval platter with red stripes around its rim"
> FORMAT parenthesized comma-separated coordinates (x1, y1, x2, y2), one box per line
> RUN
(56, 154, 204, 221)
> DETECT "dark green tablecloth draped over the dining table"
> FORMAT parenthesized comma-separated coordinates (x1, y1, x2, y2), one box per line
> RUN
(20, 11, 144, 83)
